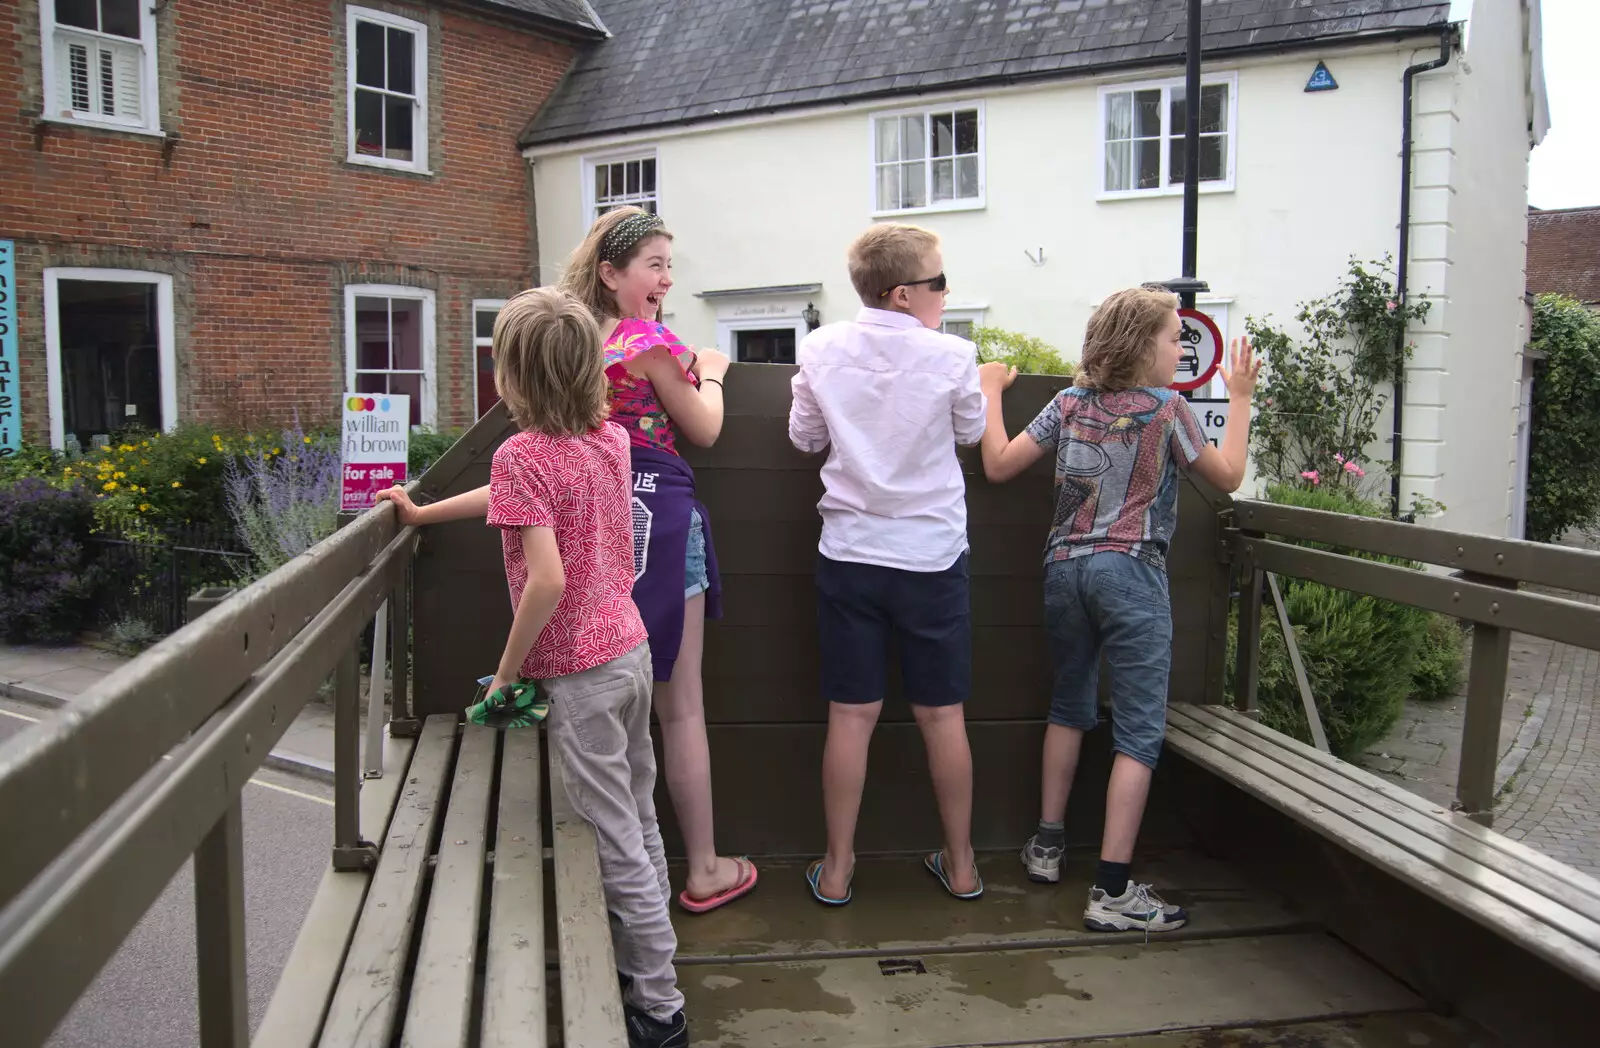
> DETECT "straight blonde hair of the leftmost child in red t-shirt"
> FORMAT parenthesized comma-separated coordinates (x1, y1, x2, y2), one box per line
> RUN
(494, 288, 610, 437)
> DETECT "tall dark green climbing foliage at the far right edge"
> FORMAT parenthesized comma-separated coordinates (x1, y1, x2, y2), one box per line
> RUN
(1528, 294, 1600, 542)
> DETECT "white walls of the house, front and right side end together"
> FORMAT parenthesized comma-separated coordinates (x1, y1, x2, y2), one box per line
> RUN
(534, 34, 1526, 531)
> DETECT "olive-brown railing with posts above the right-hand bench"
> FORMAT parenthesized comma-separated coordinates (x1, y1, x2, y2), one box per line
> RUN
(1229, 499, 1600, 826)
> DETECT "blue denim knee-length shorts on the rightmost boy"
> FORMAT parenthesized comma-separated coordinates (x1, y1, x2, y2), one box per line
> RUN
(1045, 552, 1173, 768)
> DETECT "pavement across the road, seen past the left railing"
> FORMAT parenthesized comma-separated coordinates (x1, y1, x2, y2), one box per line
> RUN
(0, 645, 377, 782)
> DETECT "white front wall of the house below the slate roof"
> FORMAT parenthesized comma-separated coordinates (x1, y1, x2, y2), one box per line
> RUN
(534, 50, 1405, 357)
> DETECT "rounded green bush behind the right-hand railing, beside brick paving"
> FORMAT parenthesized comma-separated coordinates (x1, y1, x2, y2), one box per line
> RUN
(1227, 485, 1461, 757)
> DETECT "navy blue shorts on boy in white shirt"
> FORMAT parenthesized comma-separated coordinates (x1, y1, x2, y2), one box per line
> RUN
(816, 554, 973, 706)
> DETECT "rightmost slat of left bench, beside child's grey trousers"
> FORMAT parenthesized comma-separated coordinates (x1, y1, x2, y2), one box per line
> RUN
(549, 746, 627, 1048)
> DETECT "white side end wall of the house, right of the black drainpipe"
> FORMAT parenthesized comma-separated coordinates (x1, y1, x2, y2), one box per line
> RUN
(1402, 0, 1528, 534)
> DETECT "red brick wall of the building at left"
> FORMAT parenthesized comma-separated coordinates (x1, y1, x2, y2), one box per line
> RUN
(0, 0, 573, 440)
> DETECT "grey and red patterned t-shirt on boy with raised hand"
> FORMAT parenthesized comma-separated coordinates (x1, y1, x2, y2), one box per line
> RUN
(1027, 387, 1206, 570)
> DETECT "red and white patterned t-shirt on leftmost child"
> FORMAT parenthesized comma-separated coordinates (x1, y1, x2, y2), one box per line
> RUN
(488, 422, 645, 680)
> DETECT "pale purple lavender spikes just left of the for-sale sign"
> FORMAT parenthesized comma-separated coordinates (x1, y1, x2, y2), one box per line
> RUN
(224, 418, 341, 576)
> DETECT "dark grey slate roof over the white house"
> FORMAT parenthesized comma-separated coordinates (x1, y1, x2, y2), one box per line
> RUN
(521, 0, 1450, 146)
